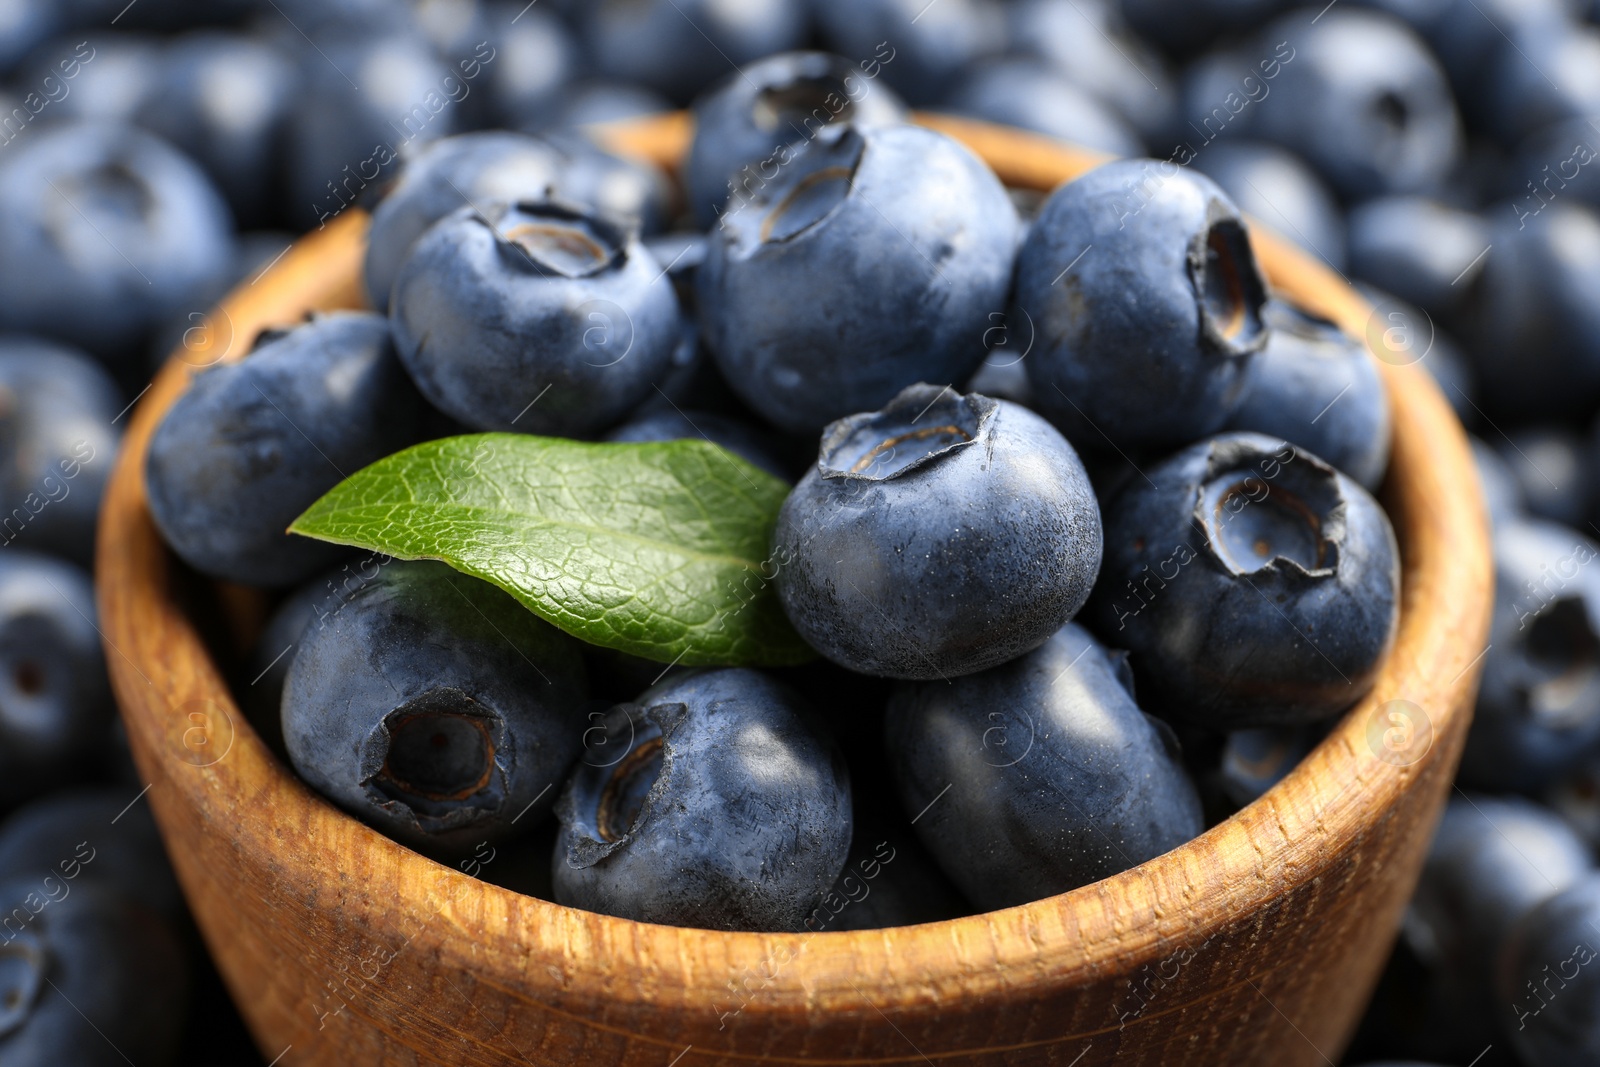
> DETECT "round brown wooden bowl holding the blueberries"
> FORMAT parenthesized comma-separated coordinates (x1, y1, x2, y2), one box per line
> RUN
(99, 115, 1491, 1067)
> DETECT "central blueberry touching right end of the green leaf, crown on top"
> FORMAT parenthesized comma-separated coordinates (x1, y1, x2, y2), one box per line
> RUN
(773, 386, 1101, 678)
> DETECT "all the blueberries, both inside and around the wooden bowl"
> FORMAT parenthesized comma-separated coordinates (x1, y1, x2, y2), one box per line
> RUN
(0, 0, 1600, 1067)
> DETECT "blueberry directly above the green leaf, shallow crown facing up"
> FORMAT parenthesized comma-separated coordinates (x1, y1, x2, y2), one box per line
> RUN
(389, 200, 680, 437)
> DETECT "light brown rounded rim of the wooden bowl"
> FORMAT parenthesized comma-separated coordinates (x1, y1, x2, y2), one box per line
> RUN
(96, 112, 1491, 1036)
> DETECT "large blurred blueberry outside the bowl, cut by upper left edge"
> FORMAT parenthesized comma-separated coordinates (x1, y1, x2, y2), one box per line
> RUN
(0, 123, 234, 357)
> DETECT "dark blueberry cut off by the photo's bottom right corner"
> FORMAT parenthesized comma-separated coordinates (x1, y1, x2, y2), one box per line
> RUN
(1494, 873, 1600, 1067)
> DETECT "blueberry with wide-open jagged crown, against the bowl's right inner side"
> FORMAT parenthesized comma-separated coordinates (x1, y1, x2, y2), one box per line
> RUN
(1088, 434, 1400, 729)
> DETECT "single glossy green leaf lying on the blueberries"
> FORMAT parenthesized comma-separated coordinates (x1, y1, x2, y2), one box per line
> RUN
(290, 434, 814, 665)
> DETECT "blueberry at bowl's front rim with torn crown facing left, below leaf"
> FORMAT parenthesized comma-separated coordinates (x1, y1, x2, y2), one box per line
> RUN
(552, 670, 851, 929)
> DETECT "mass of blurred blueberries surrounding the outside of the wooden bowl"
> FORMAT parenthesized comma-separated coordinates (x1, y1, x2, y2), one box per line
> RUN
(0, 0, 1600, 1067)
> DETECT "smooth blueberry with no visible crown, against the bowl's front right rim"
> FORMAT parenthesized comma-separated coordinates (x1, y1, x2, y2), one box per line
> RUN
(885, 622, 1205, 910)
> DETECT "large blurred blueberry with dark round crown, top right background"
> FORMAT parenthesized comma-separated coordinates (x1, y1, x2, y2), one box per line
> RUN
(1248, 8, 1461, 198)
